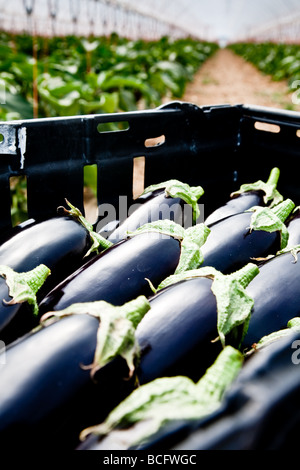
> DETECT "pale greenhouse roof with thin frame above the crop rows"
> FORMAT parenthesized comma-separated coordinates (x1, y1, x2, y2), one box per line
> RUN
(0, 0, 300, 44)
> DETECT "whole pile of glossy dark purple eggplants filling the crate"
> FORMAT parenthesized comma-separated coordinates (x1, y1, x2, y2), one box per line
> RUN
(0, 168, 300, 451)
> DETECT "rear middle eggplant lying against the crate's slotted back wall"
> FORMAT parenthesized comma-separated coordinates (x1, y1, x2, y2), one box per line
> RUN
(105, 180, 204, 243)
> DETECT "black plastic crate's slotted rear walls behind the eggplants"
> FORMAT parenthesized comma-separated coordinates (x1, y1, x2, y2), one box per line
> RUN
(0, 102, 300, 235)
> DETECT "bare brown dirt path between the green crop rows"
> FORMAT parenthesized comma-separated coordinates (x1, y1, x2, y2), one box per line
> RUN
(184, 49, 300, 111)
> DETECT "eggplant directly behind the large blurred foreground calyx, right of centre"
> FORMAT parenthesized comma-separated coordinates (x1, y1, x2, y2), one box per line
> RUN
(136, 263, 258, 384)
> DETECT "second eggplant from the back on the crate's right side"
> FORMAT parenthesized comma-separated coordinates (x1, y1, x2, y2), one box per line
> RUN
(198, 199, 294, 273)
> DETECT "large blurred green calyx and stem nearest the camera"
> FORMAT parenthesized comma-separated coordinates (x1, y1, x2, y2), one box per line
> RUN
(80, 346, 243, 448)
